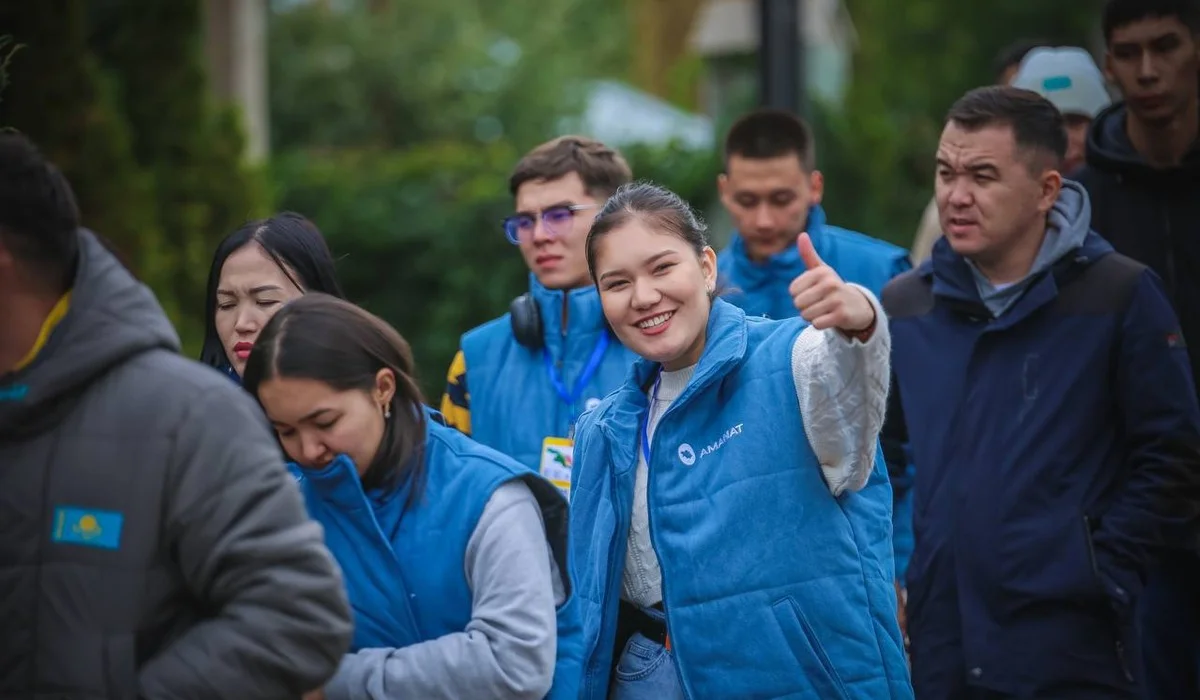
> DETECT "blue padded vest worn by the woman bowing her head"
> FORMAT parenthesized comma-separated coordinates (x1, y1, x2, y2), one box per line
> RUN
(289, 411, 582, 700)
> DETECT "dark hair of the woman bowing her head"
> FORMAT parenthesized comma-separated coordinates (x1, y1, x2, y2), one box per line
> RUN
(244, 292, 425, 504)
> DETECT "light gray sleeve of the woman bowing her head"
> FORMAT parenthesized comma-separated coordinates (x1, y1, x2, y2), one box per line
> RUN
(325, 480, 564, 700)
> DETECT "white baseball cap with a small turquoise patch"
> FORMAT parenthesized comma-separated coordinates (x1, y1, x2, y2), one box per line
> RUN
(1013, 46, 1112, 119)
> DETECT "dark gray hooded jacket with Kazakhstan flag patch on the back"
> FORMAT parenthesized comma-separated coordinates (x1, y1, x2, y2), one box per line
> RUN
(0, 232, 350, 700)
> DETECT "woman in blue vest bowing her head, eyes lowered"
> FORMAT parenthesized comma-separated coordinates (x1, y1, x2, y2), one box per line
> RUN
(244, 293, 581, 700)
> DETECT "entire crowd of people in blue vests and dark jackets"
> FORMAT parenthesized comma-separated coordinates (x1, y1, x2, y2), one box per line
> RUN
(0, 0, 1200, 700)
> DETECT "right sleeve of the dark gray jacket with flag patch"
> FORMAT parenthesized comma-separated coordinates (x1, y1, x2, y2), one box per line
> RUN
(138, 384, 352, 700)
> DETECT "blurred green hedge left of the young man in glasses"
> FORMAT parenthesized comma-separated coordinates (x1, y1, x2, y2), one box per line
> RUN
(272, 142, 719, 401)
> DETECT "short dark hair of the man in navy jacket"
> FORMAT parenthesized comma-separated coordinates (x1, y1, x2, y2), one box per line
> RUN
(946, 85, 1067, 167)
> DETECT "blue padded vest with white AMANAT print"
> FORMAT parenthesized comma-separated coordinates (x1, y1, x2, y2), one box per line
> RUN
(571, 300, 912, 700)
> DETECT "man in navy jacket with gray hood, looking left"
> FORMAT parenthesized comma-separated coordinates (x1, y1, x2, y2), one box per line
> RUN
(883, 86, 1200, 700)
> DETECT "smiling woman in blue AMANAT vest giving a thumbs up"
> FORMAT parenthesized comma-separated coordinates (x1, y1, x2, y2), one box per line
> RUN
(571, 184, 912, 700)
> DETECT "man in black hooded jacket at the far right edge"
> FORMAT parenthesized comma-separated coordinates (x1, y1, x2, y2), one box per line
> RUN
(1076, 0, 1200, 700)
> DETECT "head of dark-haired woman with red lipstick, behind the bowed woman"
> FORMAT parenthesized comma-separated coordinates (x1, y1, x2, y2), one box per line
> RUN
(200, 211, 344, 378)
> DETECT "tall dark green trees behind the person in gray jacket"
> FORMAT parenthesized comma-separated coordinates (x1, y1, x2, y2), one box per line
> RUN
(0, 0, 271, 355)
